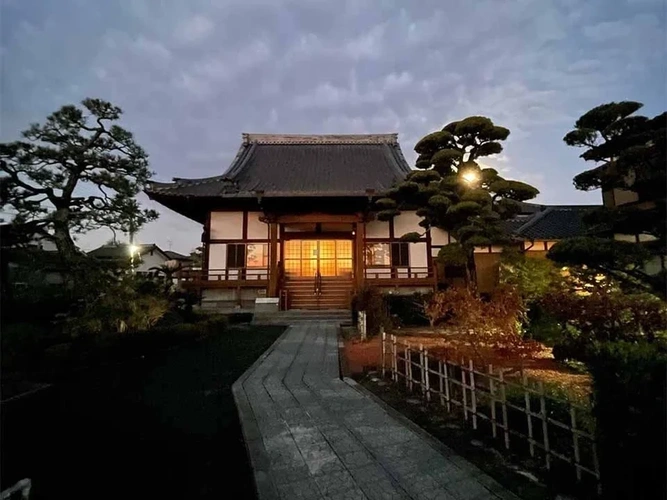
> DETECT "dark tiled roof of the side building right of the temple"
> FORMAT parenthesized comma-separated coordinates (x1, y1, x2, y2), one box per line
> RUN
(504, 205, 597, 240)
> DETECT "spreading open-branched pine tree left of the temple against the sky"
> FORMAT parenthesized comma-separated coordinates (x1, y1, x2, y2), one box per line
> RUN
(0, 99, 157, 258)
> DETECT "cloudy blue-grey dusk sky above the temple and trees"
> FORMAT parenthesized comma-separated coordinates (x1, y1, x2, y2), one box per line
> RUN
(0, 0, 667, 252)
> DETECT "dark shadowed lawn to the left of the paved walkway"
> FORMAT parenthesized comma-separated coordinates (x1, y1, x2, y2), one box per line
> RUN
(1, 325, 282, 500)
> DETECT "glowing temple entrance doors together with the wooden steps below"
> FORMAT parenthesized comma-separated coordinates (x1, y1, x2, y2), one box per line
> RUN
(283, 239, 353, 309)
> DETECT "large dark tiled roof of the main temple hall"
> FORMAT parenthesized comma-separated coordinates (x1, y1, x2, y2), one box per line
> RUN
(146, 134, 411, 202)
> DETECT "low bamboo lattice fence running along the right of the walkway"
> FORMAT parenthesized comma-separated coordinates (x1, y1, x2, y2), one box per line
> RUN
(382, 332, 600, 492)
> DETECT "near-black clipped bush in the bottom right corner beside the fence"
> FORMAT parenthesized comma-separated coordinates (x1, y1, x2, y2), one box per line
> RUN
(589, 342, 667, 500)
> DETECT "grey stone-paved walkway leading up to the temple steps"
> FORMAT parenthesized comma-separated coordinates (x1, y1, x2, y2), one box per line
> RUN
(234, 321, 516, 500)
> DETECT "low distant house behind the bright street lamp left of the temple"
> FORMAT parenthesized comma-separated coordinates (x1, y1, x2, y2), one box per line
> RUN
(88, 243, 189, 275)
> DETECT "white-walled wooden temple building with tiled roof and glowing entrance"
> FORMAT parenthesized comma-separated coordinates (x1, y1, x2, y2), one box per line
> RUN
(146, 134, 596, 309)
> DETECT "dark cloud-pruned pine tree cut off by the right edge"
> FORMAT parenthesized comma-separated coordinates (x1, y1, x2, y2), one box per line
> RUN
(548, 101, 667, 296)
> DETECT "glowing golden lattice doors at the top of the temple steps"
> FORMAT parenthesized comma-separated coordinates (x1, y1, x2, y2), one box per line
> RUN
(283, 240, 352, 277)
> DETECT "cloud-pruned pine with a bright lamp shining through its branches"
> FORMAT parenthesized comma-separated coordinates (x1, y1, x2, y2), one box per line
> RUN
(377, 116, 539, 285)
